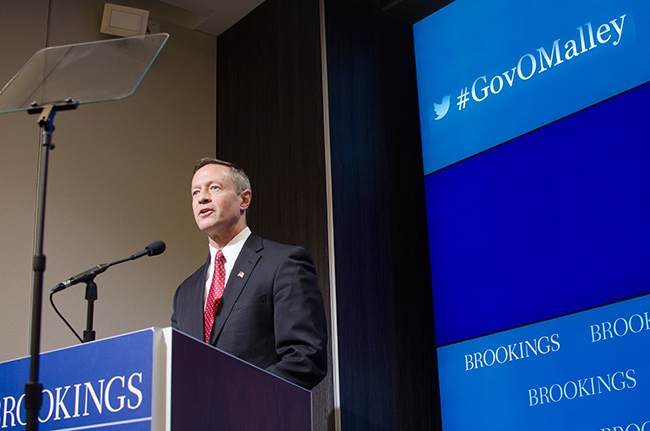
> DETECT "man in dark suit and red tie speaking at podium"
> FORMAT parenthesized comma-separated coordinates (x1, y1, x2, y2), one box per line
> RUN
(172, 158, 327, 389)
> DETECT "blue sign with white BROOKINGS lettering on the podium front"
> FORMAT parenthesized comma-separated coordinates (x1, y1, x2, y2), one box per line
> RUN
(0, 329, 154, 431)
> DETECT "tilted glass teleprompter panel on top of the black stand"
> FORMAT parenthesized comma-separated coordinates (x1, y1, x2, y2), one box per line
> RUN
(0, 33, 169, 113)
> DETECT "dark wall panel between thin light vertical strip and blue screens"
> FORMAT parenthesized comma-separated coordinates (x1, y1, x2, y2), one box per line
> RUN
(325, 0, 440, 431)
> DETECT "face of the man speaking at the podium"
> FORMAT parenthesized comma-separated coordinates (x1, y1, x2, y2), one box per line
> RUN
(192, 164, 250, 241)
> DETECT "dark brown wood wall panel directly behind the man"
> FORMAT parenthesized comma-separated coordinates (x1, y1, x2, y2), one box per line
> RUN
(217, 0, 334, 431)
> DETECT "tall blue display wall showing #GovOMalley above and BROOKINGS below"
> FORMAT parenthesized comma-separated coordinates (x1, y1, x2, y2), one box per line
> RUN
(414, 0, 650, 431)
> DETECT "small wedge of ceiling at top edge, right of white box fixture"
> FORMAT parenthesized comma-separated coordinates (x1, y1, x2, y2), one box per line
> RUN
(150, 0, 264, 36)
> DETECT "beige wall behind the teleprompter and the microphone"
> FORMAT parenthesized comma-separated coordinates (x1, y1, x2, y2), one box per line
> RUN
(0, 0, 216, 361)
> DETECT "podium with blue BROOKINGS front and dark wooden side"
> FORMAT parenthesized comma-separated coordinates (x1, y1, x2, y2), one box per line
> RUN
(0, 328, 312, 431)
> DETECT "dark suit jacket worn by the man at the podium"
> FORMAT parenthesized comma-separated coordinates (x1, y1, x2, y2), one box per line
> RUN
(172, 234, 327, 389)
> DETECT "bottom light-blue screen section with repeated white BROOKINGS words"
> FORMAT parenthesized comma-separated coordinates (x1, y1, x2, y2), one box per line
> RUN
(438, 295, 650, 431)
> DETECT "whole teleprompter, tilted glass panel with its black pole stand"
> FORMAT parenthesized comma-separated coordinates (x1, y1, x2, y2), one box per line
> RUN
(0, 33, 169, 431)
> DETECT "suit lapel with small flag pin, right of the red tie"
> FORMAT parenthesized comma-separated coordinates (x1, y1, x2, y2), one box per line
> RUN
(210, 233, 263, 345)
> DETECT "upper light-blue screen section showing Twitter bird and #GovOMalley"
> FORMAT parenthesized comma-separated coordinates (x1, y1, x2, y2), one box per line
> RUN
(414, 0, 650, 174)
